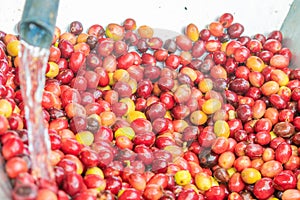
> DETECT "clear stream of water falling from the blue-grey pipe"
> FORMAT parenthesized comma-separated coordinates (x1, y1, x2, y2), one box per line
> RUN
(19, 41, 54, 181)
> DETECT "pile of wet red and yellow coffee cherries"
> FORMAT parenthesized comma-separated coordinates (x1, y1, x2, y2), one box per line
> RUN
(0, 13, 300, 200)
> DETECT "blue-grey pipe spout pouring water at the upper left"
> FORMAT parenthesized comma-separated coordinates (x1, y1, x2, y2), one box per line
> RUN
(20, 0, 59, 49)
